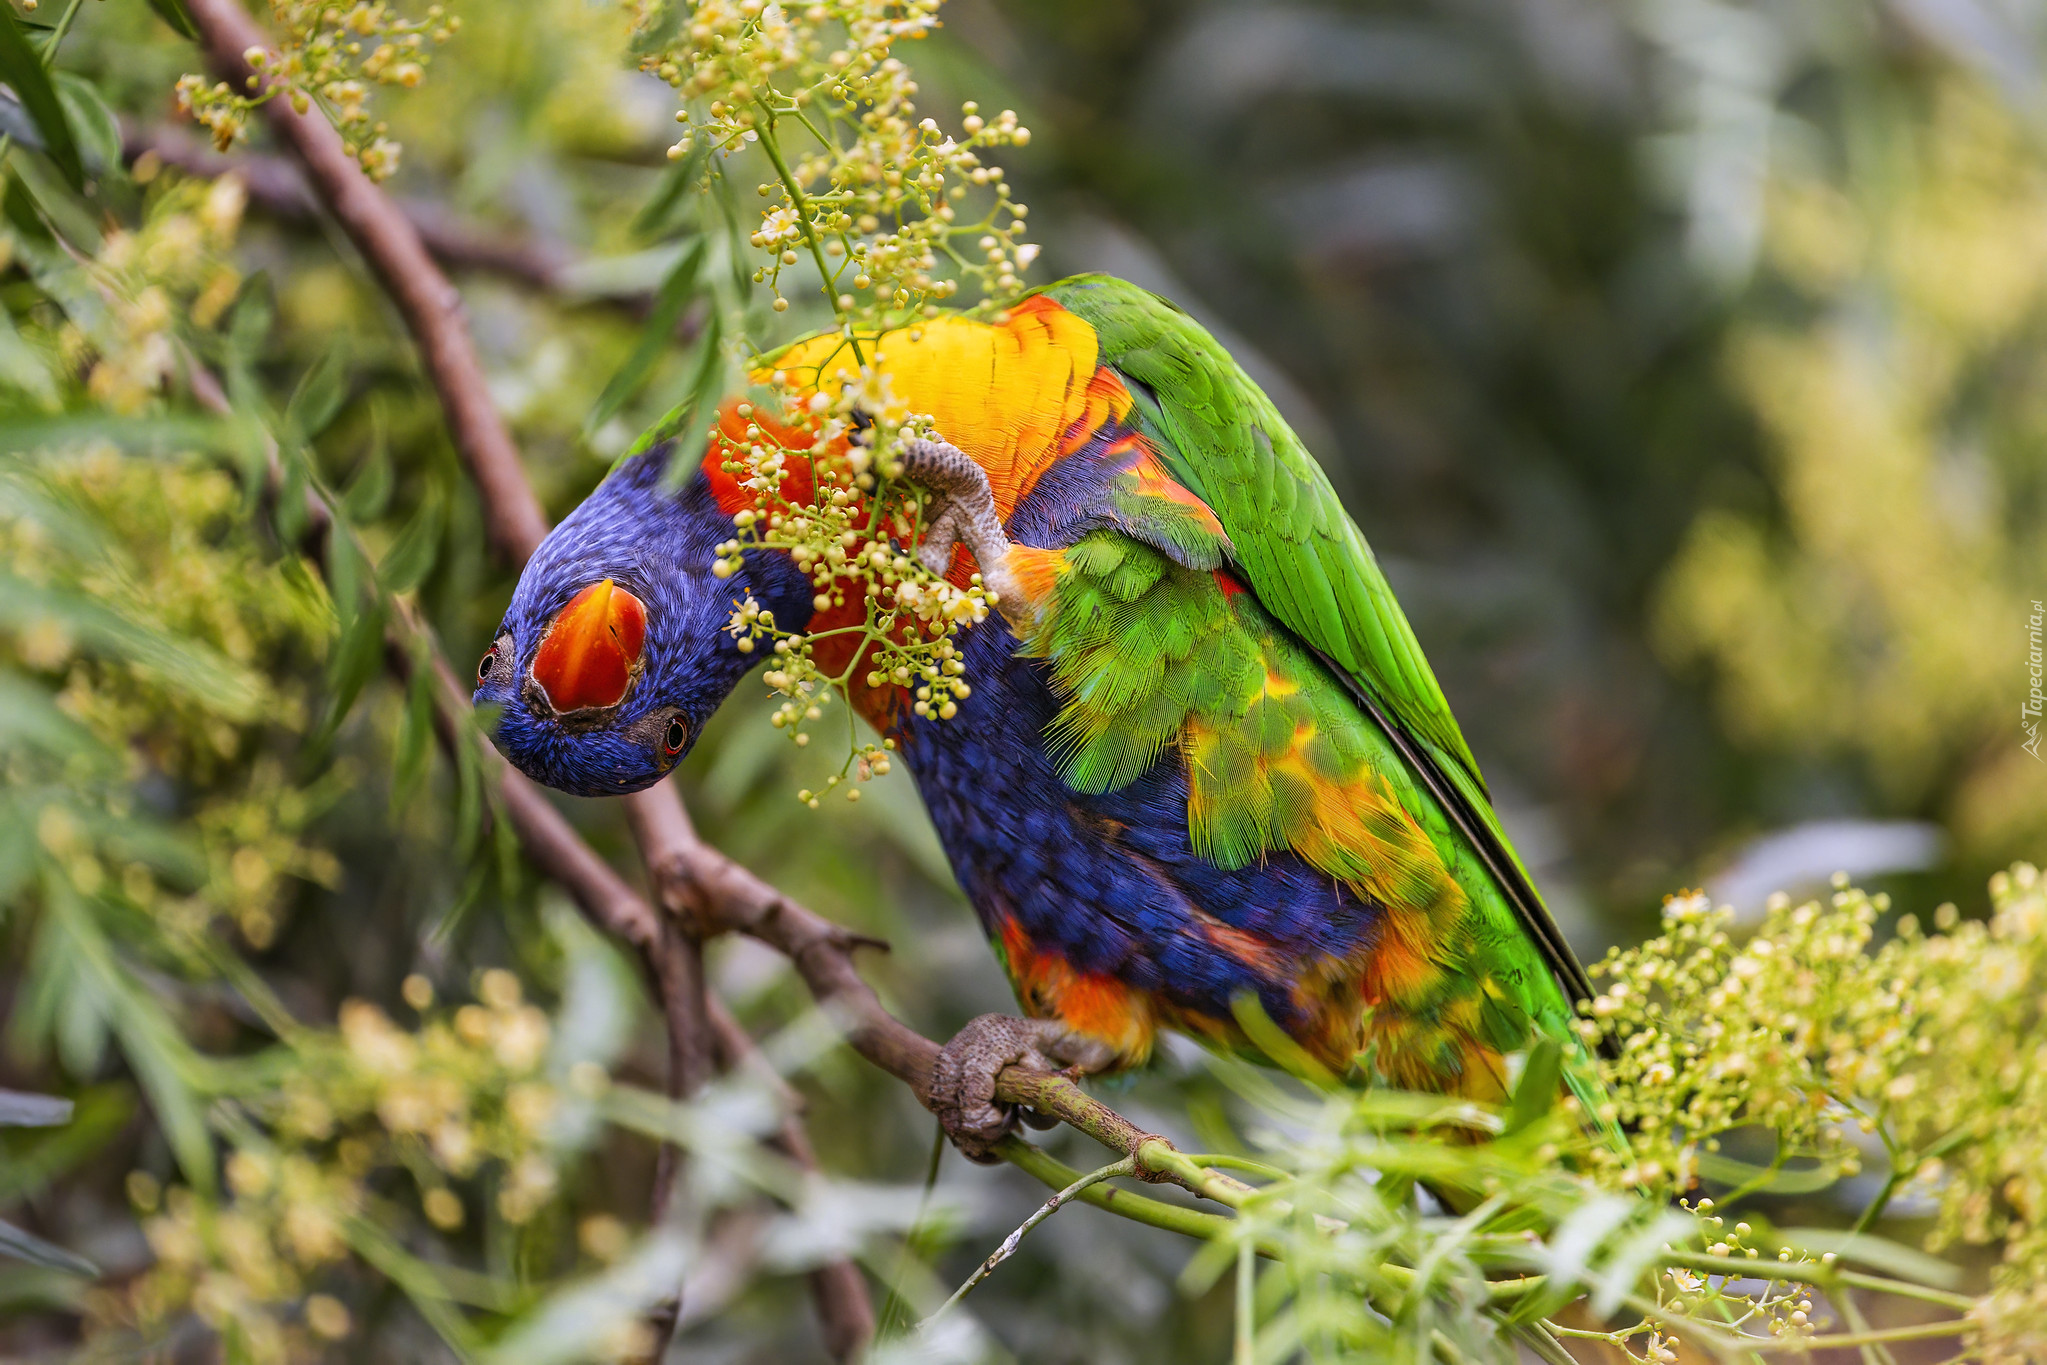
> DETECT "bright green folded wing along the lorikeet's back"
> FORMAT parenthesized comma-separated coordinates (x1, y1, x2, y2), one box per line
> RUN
(1042, 274, 1593, 1023)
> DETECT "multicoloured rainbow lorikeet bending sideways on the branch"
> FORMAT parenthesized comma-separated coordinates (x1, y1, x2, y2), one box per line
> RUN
(475, 276, 1597, 1154)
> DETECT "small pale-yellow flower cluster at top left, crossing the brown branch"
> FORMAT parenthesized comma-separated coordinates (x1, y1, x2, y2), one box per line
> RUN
(178, 0, 463, 180)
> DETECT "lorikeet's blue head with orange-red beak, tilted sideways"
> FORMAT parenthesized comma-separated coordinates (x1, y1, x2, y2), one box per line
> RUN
(475, 446, 811, 796)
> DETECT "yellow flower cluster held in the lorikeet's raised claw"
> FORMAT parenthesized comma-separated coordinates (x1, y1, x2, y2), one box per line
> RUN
(712, 370, 995, 806)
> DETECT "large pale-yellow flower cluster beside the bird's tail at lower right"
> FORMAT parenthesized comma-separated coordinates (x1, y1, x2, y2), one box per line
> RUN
(1580, 864, 2047, 1359)
